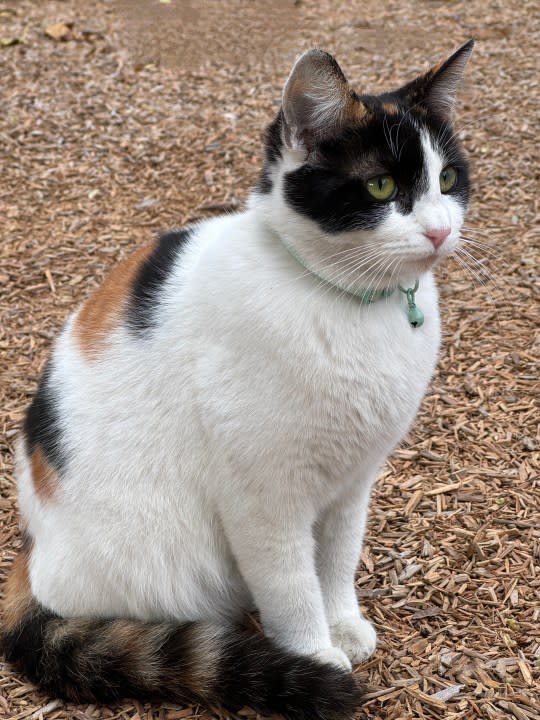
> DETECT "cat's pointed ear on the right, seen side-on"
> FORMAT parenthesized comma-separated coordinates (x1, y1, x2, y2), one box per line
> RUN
(400, 40, 474, 122)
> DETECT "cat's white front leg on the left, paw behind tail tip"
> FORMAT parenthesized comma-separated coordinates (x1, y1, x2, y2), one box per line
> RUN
(217, 499, 351, 670)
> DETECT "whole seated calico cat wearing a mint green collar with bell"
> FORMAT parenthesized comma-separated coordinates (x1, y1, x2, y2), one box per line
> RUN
(3, 41, 473, 720)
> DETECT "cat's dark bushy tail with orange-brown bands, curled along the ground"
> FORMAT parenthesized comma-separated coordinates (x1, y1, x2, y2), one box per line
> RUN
(2, 553, 360, 720)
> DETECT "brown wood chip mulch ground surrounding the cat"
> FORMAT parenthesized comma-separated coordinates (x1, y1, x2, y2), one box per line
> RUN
(0, 0, 540, 720)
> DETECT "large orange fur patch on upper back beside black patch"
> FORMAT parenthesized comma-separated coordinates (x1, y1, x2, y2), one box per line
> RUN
(75, 242, 155, 358)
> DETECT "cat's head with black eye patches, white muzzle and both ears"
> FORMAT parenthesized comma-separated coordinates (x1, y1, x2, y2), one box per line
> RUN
(253, 40, 473, 289)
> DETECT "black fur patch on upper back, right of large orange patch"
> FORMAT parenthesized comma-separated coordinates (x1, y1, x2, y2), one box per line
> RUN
(128, 228, 193, 335)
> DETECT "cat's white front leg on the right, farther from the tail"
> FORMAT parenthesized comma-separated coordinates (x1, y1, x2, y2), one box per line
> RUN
(316, 482, 377, 663)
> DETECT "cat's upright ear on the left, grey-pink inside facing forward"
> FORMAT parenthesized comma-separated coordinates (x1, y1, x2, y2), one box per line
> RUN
(282, 50, 363, 152)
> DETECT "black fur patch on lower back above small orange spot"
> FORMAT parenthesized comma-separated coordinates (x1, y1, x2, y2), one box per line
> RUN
(24, 360, 66, 472)
